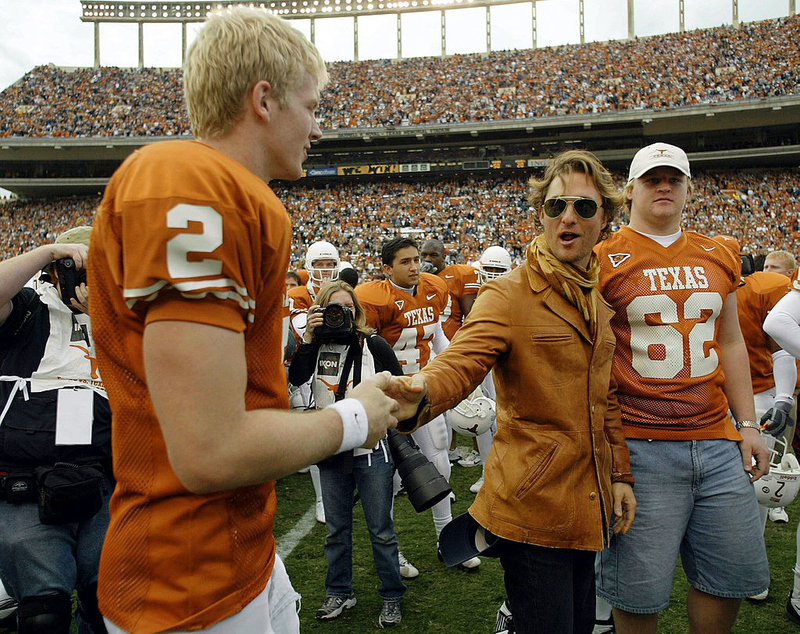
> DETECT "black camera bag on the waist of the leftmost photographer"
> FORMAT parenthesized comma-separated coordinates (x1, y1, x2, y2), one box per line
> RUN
(35, 462, 105, 524)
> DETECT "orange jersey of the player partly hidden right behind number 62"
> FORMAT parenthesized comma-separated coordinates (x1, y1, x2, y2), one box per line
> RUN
(736, 271, 790, 394)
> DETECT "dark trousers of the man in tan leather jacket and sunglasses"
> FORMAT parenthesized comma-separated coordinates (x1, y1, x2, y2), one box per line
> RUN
(500, 540, 597, 634)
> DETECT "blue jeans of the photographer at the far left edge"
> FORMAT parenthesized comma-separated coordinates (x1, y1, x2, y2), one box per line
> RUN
(0, 478, 113, 634)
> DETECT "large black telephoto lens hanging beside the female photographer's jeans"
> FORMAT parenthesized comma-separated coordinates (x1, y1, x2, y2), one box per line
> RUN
(389, 429, 452, 513)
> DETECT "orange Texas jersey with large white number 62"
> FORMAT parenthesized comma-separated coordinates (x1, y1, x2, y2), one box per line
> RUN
(596, 227, 741, 440)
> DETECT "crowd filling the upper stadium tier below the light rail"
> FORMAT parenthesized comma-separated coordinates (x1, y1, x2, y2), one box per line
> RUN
(0, 16, 800, 137)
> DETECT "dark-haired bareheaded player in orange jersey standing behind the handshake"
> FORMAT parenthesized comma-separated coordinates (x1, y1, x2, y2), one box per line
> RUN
(356, 236, 480, 576)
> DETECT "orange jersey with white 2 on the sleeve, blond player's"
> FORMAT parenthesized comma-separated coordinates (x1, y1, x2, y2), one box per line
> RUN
(88, 141, 291, 634)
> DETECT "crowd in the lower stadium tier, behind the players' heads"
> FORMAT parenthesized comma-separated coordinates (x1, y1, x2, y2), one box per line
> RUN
(0, 169, 800, 268)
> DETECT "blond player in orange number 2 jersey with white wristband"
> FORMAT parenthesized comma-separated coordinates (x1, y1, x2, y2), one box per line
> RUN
(88, 7, 397, 634)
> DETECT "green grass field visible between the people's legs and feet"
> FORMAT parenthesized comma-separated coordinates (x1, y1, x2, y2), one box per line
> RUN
(275, 439, 800, 634)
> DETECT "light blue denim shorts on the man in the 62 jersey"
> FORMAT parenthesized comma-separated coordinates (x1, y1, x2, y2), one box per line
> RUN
(596, 439, 769, 614)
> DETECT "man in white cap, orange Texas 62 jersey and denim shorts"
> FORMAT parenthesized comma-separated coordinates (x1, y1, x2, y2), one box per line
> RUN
(596, 143, 769, 634)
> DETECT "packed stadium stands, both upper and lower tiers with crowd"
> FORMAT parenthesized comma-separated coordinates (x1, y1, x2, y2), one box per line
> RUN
(0, 16, 800, 274)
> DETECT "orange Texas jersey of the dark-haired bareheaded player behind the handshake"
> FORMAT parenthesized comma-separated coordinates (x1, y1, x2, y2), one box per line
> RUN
(356, 273, 450, 375)
